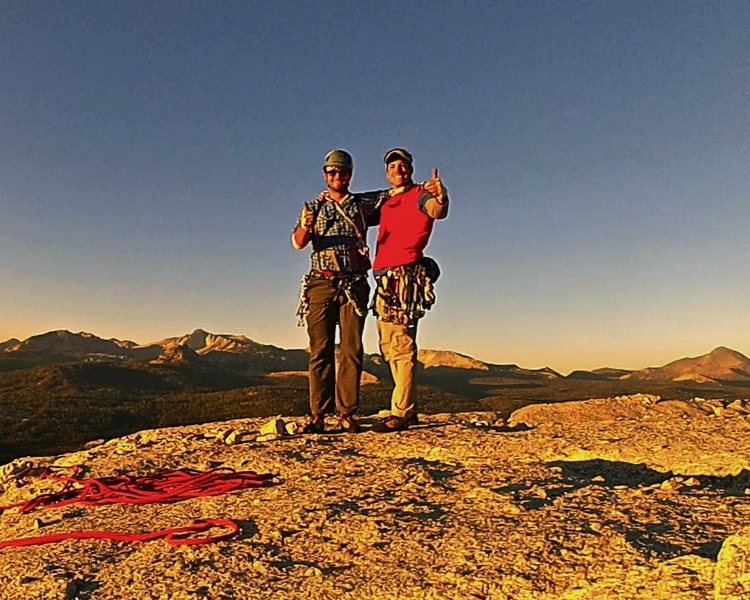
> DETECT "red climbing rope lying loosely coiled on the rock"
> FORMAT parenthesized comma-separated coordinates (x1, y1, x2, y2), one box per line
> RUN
(0, 467, 274, 550)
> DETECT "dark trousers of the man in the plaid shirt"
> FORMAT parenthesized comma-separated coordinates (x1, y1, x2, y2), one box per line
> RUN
(307, 277, 370, 416)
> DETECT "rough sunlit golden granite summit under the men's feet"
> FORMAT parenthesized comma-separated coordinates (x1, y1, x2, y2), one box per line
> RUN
(0, 396, 750, 600)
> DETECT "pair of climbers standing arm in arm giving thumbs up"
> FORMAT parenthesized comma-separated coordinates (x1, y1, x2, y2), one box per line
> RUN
(292, 148, 448, 433)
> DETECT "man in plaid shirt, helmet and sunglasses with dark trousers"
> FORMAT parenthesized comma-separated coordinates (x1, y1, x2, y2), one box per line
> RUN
(292, 150, 384, 433)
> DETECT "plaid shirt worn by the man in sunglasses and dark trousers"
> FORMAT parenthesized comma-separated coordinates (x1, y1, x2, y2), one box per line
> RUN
(300, 192, 388, 275)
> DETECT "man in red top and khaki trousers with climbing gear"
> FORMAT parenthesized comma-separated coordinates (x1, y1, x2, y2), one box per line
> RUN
(373, 148, 448, 433)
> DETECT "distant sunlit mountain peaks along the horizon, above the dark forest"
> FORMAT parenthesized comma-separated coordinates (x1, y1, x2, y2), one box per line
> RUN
(0, 329, 750, 383)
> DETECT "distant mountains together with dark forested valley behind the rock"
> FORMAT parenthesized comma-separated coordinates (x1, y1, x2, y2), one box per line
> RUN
(0, 329, 750, 460)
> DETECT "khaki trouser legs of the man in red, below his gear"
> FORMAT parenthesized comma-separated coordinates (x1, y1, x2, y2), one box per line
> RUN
(378, 319, 417, 417)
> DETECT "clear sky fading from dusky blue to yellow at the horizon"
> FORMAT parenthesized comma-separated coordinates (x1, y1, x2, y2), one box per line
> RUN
(0, 0, 750, 373)
